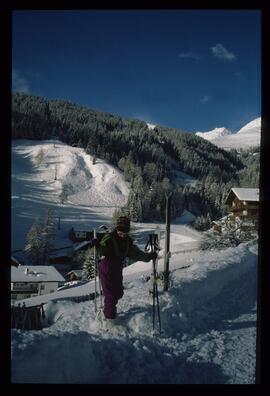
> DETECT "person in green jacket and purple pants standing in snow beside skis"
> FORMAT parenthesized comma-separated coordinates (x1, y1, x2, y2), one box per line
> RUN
(98, 216, 157, 323)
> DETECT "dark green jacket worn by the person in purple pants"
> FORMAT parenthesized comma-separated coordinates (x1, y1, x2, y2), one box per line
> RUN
(98, 231, 151, 263)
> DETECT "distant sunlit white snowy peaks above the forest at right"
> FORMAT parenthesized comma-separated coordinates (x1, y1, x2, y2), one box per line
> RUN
(196, 117, 261, 149)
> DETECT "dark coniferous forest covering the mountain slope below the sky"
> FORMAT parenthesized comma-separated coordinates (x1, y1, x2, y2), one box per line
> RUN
(12, 92, 260, 229)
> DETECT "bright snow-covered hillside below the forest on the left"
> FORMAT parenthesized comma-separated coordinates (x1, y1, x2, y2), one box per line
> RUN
(11, 140, 129, 251)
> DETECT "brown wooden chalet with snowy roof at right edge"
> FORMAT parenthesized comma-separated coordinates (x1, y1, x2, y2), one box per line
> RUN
(225, 188, 259, 225)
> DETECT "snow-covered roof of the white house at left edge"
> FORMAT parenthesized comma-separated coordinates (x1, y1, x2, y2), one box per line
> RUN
(11, 265, 65, 282)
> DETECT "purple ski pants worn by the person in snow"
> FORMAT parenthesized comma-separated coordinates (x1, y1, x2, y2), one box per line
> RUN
(99, 258, 124, 319)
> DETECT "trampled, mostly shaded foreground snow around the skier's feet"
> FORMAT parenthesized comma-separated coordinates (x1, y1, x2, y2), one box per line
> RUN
(12, 244, 257, 384)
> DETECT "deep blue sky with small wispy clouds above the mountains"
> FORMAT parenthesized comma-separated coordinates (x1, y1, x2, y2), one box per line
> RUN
(12, 9, 261, 132)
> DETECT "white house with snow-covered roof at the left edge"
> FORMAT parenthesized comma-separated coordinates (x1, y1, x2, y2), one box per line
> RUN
(11, 265, 65, 301)
